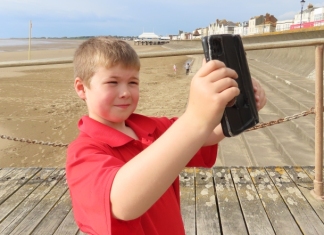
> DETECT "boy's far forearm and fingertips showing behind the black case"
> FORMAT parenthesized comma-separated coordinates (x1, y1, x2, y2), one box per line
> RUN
(204, 78, 267, 146)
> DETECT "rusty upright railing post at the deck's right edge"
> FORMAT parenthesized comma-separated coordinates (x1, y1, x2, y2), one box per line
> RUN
(311, 45, 324, 201)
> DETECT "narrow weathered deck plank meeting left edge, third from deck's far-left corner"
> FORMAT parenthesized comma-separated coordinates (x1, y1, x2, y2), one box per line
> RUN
(0, 168, 54, 222)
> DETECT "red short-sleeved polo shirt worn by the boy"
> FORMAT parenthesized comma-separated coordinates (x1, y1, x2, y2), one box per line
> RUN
(66, 114, 217, 235)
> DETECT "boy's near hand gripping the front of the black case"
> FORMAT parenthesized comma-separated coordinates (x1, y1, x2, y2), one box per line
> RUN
(185, 60, 240, 130)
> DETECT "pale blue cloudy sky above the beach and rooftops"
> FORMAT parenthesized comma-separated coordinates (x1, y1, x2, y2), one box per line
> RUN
(0, 0, 324, 38)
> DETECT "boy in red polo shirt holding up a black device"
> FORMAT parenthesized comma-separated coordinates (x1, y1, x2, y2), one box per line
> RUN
(66, 37, 265, 235)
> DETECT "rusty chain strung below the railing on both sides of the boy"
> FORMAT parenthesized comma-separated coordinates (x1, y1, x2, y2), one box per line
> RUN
(0, 107, 315, 147)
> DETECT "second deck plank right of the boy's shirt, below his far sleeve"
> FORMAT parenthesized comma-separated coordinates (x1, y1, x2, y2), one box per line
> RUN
(196, 168, 221, 235)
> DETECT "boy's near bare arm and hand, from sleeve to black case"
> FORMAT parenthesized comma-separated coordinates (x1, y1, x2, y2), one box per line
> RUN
(110, 61, 239, 220)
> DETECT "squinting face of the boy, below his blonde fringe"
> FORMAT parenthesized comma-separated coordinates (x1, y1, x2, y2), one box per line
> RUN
(78, 65, 139, 127)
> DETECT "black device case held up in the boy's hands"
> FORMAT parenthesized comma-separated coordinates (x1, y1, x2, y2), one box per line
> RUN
(202, 34, 259, 137)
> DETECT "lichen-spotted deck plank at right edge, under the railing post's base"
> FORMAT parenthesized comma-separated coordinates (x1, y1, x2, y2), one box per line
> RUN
(285, 167, 324, 223)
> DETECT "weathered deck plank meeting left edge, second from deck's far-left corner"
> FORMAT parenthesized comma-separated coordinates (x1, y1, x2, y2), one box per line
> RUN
(0, 168, 40, 205)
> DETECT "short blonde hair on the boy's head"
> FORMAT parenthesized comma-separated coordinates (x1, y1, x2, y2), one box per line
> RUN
(73, 37, 140, 87)
